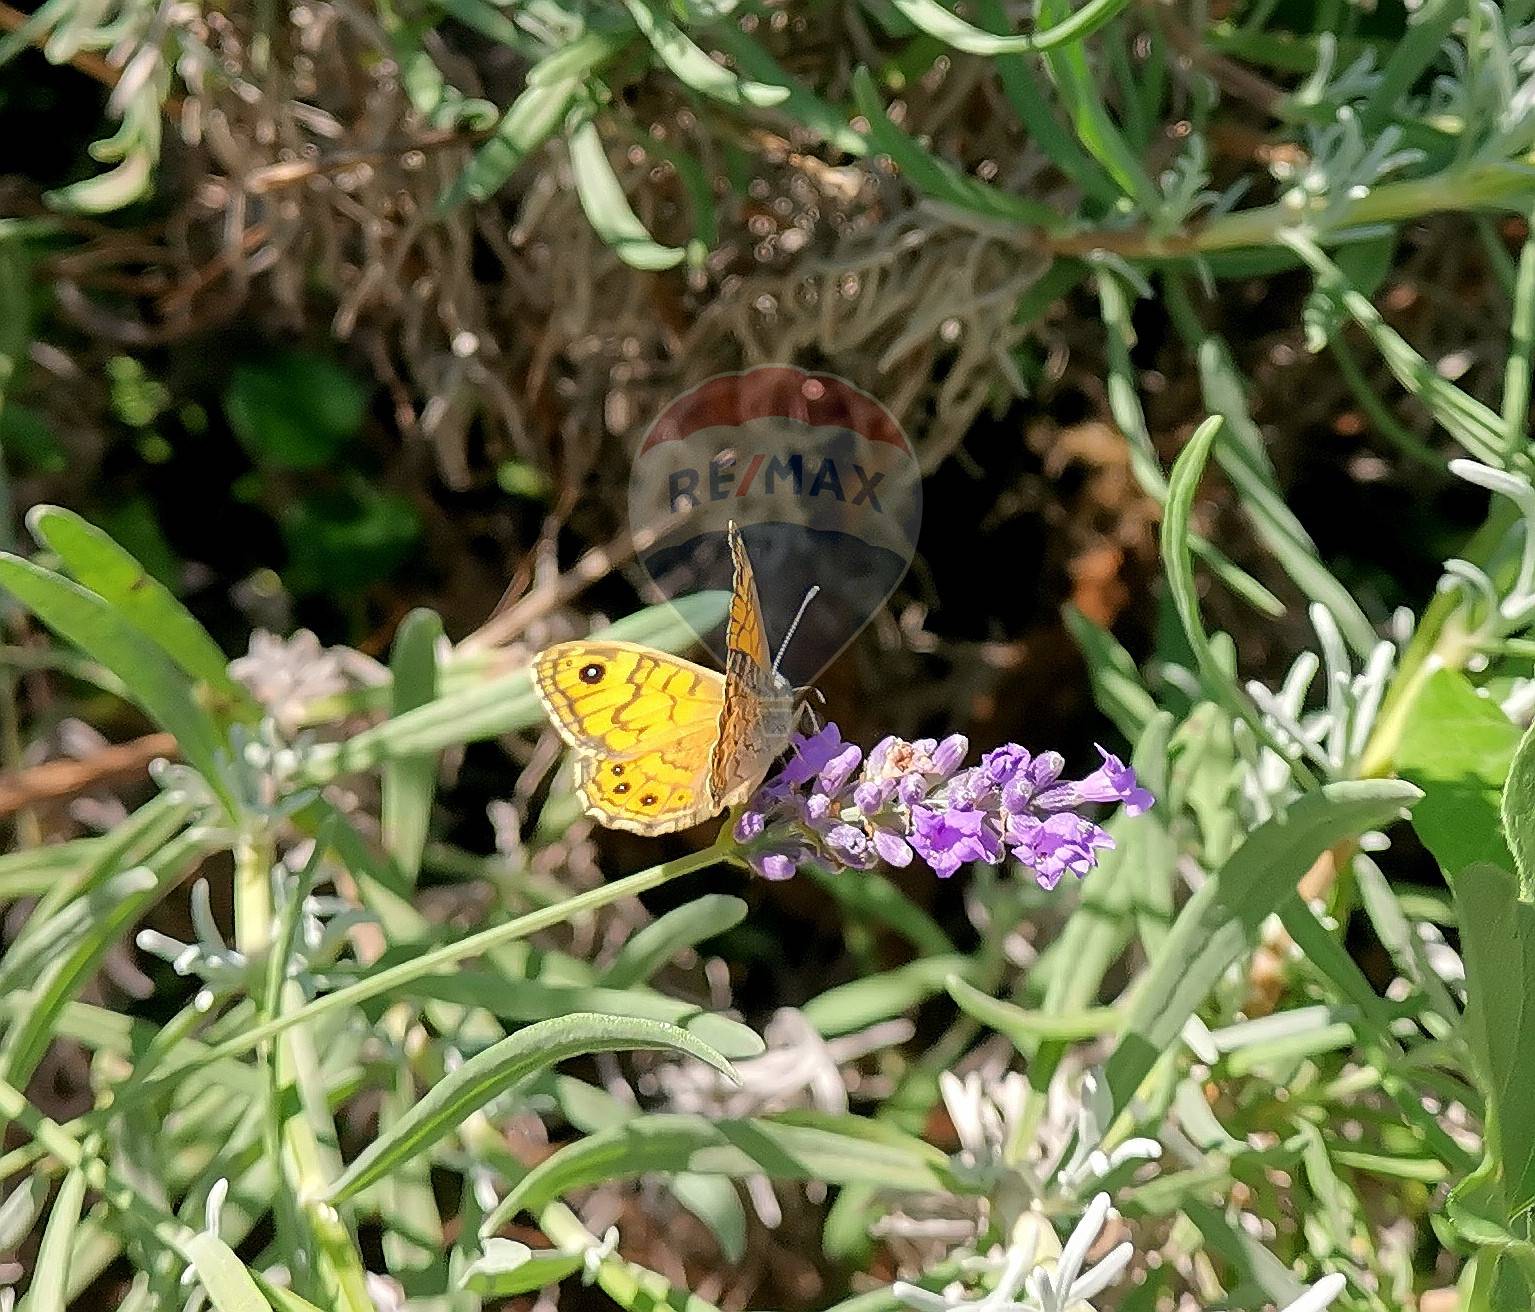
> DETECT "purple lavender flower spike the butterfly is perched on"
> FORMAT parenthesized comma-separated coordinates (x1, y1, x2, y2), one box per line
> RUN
(735, 724, 1154, 888)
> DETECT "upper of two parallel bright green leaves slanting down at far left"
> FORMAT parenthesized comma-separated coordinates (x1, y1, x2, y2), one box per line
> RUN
(26, 505, 255, 710)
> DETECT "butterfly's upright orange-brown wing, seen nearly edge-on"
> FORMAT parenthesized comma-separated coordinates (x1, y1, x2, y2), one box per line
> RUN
(709, 523, 794, 807)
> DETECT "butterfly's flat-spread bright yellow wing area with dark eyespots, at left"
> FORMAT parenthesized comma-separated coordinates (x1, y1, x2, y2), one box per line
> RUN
(533, 641, 725, 835)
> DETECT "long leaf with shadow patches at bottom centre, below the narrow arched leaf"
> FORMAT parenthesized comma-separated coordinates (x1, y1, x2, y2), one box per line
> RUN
(480, 1114, 955, 1234)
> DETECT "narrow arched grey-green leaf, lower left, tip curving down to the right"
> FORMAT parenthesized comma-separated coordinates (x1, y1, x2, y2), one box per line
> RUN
(325, 1013, 734, 1203)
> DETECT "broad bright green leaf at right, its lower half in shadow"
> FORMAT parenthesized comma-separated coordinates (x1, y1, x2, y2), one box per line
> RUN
(1395, 669, 1520, 875)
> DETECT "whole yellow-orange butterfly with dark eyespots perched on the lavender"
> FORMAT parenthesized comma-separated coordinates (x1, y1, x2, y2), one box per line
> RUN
(533, 523, 814, 835)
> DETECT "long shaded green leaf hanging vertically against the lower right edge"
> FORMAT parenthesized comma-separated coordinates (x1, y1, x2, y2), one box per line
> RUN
(1451, 864, 1535, 1225)
